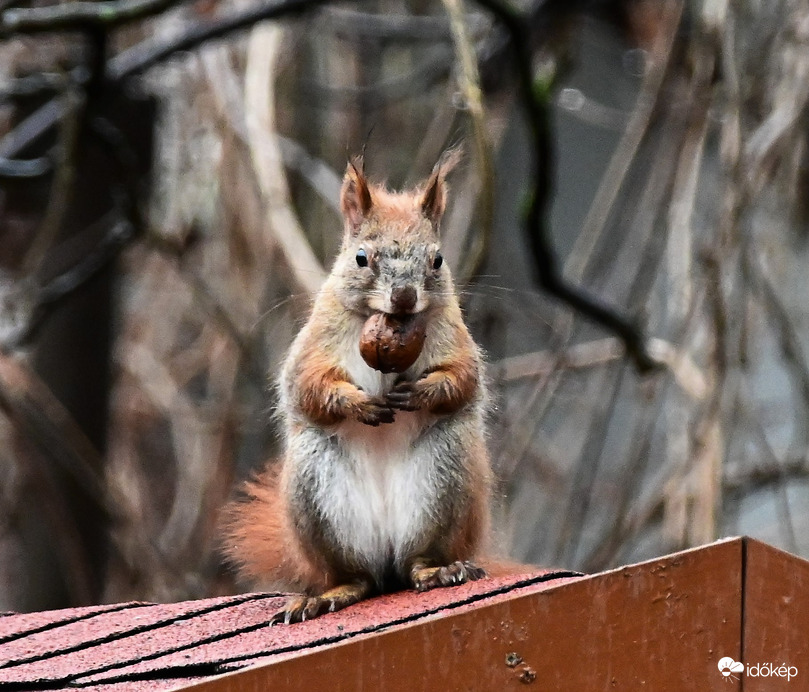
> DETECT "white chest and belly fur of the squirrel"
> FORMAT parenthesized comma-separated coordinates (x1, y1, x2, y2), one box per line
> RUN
(321, 322, 433, 576)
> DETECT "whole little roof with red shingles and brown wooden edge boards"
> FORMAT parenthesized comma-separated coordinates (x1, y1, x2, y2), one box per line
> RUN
(6, 538, 809, 692)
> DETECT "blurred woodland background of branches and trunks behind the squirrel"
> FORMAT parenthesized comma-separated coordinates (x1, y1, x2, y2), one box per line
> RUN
(0, 0, 809, 610)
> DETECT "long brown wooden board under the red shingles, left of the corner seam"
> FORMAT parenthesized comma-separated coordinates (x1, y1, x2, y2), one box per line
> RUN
(186, 538, 740, 692)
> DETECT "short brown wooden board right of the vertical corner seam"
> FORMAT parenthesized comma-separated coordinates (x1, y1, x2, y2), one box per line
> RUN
(740, 538, 809, 692)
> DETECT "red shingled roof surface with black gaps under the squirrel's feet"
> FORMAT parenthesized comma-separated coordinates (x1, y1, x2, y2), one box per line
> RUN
(0, 569, 572, 692)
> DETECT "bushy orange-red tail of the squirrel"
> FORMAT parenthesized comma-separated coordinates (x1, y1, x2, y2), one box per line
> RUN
(221, 464, 325, 591)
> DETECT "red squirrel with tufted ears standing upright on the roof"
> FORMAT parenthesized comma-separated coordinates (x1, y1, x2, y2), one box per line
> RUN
(218, 151, 491, 623)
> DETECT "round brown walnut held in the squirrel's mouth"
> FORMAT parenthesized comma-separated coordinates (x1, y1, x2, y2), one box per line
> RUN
(360, 312, 427, 373)
